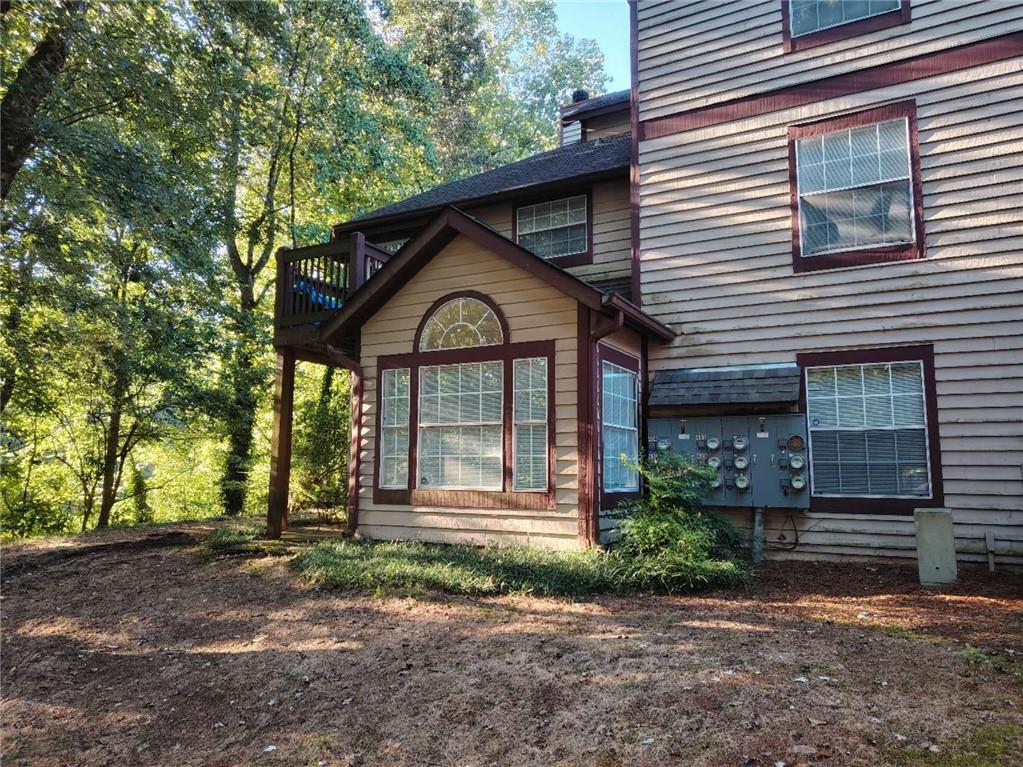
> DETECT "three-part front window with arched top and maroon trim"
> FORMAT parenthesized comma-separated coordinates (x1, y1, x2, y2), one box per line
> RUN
(374, 291, 554, 508)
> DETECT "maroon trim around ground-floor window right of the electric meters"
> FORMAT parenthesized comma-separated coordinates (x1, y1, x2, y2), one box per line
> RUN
(796, 344, 945, 515)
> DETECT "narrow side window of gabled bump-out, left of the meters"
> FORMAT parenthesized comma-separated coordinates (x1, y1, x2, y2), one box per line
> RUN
(601, 361, 639, 493)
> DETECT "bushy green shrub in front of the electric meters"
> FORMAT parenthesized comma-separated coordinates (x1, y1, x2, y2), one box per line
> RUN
(615, 451, 750, 592)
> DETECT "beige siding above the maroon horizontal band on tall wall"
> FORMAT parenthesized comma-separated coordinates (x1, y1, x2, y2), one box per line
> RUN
(638, 0, 1023, 120)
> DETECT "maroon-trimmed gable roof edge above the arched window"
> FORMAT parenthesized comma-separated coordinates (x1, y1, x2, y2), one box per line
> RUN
(319, 207, 675, 343)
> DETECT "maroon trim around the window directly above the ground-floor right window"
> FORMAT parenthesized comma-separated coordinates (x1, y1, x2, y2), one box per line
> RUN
(789, 100, 927, 273)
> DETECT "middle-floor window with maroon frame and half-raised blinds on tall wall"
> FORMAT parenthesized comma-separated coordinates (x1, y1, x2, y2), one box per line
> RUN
(789, 102, 923, 271)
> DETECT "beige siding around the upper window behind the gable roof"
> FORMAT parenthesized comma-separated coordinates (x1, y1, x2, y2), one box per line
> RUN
(469, 179, 631, 280)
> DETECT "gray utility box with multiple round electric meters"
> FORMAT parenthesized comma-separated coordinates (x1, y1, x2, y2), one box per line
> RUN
(647, 415, 810, 509)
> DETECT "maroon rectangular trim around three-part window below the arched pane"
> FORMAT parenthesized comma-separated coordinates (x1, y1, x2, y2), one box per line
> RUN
(373, 335, 557, 509)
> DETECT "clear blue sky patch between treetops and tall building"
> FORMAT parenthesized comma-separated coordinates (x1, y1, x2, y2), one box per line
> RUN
(554, 0, 630, 92)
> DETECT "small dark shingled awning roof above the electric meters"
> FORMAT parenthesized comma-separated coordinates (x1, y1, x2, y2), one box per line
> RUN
(650, 362, 800, 406)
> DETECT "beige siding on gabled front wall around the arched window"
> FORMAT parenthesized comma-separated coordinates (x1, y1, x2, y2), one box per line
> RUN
(359, 237, 580, 548)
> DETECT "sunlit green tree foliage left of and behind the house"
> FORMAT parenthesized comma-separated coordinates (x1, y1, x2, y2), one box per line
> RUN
(0, 0, 605, 537)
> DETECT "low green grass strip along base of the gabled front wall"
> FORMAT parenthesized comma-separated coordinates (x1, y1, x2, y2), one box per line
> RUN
(293, 541, 748, 596)
